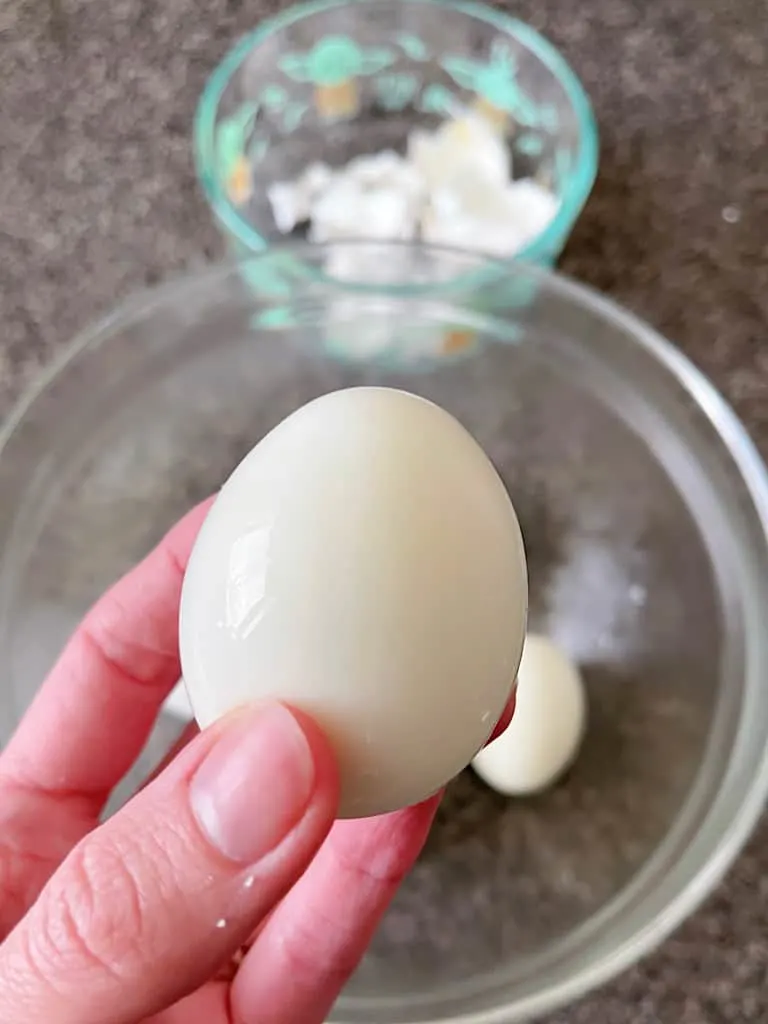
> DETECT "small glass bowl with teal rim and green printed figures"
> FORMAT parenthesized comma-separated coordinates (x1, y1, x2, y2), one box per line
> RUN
(195, 0, 597, 264)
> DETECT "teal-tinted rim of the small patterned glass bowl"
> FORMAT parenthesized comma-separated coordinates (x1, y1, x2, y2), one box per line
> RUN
(193, 0, 598, 262)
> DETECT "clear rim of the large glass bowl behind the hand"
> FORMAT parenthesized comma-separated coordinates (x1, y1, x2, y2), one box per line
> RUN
(0, 244, 768, 1024)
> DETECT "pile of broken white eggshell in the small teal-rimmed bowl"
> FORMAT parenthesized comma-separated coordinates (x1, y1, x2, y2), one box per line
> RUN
(267, 113, 559, 258)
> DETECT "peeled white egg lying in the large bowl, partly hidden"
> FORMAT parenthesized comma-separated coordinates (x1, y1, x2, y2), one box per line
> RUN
(472, 634, 587, 797)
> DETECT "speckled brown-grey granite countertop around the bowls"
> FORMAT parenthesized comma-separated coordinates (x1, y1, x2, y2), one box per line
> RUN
(0, 0, 768, 1024)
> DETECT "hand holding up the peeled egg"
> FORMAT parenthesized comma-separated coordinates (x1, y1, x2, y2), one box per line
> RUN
(0, 503, 438, 1024)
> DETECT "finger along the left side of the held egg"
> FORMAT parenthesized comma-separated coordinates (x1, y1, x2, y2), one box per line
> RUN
(0, 499, 212, 813)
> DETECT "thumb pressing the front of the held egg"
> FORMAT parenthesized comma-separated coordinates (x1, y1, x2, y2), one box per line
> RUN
(0, 703, 338, 1024)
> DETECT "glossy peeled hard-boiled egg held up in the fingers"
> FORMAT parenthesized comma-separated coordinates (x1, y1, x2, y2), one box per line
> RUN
(180, 388, 527, 817)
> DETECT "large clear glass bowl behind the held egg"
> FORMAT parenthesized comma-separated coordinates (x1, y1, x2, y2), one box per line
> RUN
(0, 247, 768, 1024)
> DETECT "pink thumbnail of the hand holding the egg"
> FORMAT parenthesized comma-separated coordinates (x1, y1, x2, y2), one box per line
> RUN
(189, 703, 314, 864)
